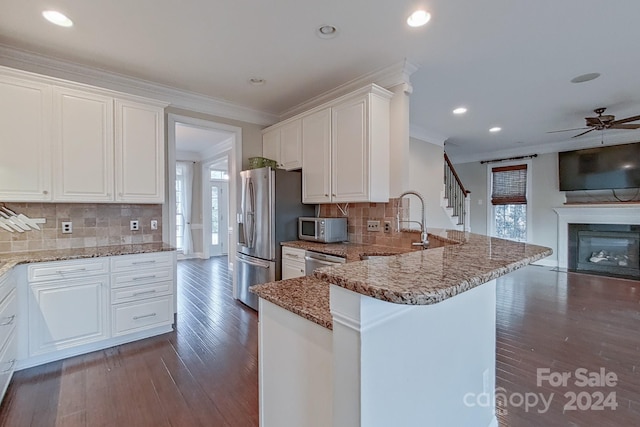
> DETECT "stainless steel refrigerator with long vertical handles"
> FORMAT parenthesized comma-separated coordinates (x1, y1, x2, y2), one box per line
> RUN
(235, 167, 315, 310)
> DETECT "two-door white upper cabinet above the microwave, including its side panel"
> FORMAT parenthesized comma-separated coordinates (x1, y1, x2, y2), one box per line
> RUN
(302, 85, 391, 203)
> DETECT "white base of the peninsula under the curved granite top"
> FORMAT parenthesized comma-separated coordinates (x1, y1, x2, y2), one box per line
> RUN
(259, 280, 498, 427)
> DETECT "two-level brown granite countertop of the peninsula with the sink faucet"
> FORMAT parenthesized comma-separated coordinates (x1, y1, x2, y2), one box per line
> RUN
(251, 230, 553, 329)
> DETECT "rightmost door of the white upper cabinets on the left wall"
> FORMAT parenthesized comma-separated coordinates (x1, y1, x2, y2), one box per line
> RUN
(115, 99, 164, 203)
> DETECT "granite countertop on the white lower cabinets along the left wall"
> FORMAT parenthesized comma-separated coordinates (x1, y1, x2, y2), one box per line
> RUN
(0, 243, 176, 275)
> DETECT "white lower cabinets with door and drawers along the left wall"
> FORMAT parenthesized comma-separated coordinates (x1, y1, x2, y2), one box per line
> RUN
(20, 252, 176, 370)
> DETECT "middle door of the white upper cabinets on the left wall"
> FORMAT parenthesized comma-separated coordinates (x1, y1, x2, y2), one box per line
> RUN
(53, 87, 114, 202)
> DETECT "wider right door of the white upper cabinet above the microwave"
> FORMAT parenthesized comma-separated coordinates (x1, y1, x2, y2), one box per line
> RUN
(331, 98, 369, 202)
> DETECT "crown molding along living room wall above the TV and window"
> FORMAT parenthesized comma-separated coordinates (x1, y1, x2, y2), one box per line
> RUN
(447, 132, 640, 164)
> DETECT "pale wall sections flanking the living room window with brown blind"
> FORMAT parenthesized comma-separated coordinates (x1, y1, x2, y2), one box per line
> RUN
(454, 153, 565, 262)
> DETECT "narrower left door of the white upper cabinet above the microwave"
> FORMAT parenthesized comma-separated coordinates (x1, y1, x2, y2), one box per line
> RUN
(302, 108, 331, 203)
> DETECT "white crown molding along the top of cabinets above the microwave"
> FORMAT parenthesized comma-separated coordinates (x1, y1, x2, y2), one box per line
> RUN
(280, 59, 418, 120)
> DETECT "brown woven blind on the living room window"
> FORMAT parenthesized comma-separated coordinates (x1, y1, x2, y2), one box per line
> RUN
(491, 165, 527, 205)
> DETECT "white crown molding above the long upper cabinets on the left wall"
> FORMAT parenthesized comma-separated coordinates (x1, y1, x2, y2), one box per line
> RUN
(0, 44, 279, 126)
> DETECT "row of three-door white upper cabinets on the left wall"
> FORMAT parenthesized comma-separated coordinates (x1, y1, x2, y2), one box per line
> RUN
(0, 67, 166, 203)
